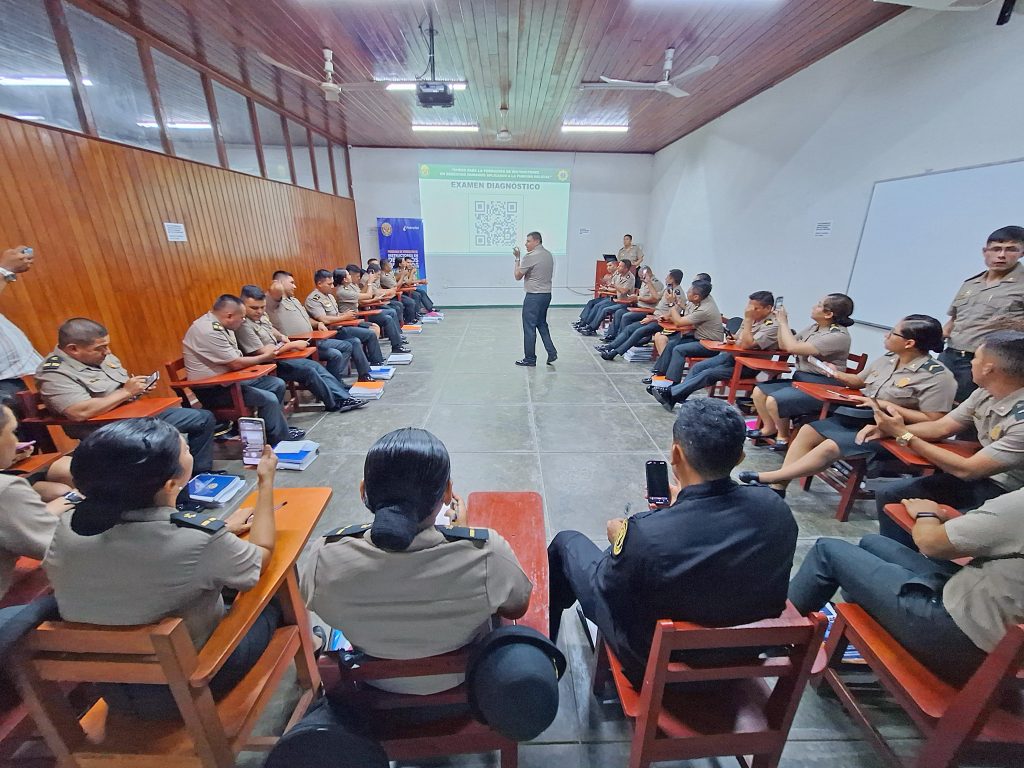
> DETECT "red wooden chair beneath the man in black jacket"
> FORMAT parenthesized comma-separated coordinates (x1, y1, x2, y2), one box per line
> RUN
(598, 603, 825, 768)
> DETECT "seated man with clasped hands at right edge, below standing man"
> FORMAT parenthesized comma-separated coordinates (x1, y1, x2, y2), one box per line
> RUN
(863, 331, 1024, 547)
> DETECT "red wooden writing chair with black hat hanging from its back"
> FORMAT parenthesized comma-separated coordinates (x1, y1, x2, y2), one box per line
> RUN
(319, 493, 548, 768)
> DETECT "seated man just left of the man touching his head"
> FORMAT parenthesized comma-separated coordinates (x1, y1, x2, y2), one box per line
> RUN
(234, 286, 367, 413)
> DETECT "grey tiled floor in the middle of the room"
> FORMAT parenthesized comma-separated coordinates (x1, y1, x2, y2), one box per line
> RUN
(16, 308, 933, 768)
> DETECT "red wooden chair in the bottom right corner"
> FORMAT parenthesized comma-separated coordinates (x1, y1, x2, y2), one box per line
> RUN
(823, 603, 1024, 768)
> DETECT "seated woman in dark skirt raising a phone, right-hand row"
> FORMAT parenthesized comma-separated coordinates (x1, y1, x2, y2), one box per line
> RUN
(748, 293, 853, 451)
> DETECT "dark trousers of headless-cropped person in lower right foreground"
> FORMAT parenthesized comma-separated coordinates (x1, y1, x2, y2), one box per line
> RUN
(790, 535, 986, 686)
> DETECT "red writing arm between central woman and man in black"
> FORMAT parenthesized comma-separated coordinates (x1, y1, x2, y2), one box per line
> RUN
(468, 492, 550, 636)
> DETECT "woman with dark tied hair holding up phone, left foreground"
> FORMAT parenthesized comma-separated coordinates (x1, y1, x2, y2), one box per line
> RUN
(43, 419, 281, 719)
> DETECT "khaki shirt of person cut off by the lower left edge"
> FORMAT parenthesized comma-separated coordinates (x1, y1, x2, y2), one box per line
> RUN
(0, 474, 59, 597)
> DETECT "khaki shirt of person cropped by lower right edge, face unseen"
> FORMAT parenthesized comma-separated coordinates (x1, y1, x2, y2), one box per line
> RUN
(942, 490, 1024, 651)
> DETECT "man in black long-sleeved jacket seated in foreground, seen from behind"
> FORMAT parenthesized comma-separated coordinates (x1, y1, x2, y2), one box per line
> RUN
(548, 398, 797, 690)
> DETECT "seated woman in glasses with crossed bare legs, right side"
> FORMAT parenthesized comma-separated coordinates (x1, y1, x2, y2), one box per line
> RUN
(739, 314, 956, 495)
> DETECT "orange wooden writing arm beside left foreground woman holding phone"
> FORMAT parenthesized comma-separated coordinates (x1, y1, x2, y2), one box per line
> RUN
(190, 488, 333, 689)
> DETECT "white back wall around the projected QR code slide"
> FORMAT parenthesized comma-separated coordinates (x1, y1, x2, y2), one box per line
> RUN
(349, 147, 653, 306)
